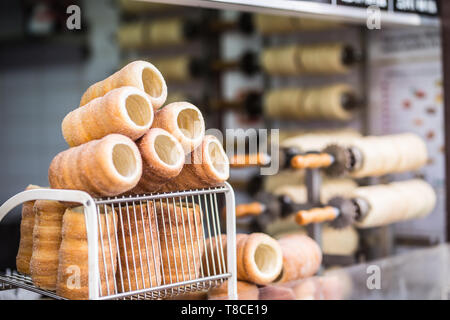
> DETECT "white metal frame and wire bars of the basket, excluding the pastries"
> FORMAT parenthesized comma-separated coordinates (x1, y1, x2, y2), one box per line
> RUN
(0, 183, 237, 300)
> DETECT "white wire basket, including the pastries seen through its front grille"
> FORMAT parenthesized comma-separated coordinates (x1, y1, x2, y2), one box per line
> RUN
(0, 183, 237, 300)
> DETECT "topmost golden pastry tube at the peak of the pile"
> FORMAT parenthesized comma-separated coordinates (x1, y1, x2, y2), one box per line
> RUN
(80, 61, 167, 111)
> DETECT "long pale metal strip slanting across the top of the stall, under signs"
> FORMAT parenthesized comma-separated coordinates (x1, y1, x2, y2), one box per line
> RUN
(139, 0, 440, 27)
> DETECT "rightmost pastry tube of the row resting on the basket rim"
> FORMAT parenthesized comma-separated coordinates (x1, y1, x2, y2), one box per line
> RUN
(163, 135, 230, 191)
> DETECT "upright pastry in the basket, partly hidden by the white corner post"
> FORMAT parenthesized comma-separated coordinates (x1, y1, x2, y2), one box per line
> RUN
(56, 207, 117, 300)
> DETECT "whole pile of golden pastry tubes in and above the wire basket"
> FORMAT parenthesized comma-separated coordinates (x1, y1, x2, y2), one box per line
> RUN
(17, 61, 229, 299)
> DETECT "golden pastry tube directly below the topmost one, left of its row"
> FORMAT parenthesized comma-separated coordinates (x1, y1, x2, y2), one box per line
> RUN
(62, 87, 153, 147)
